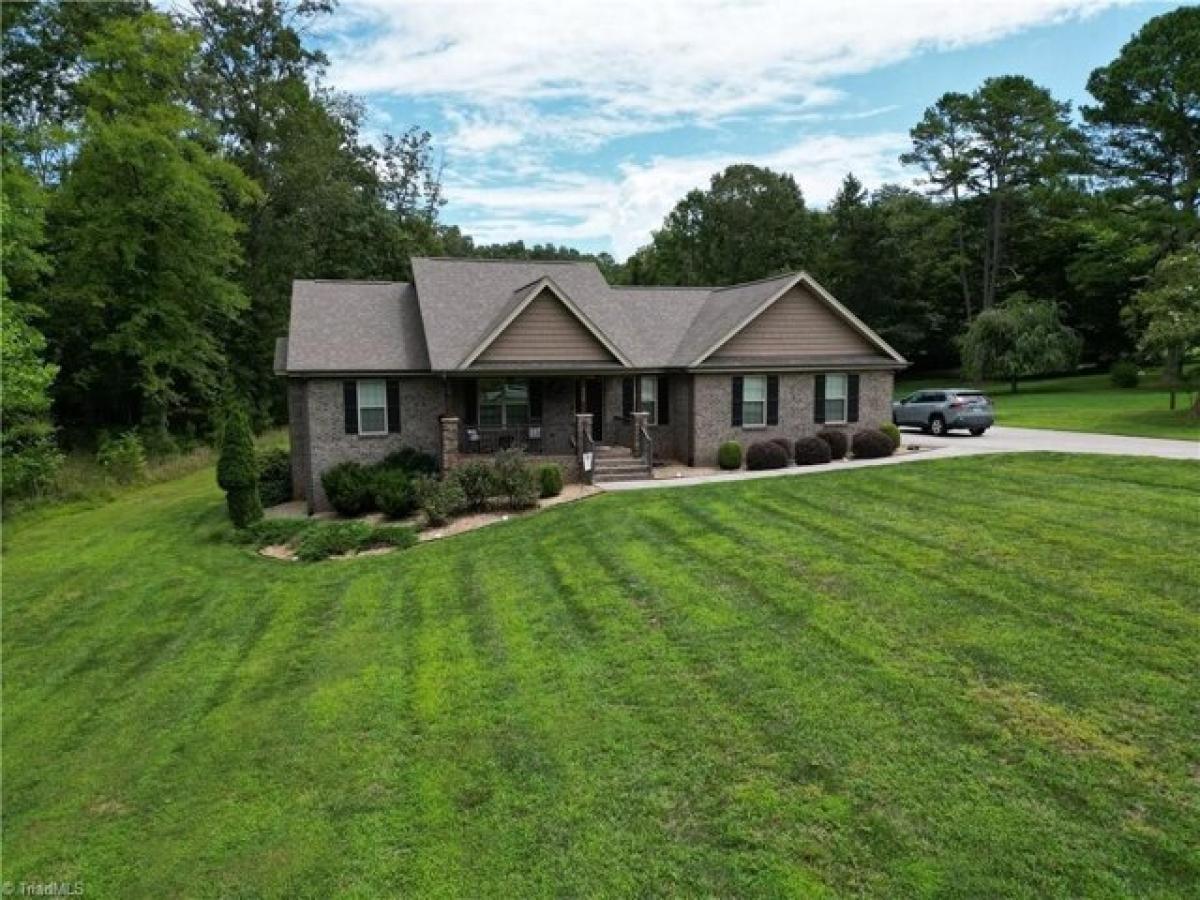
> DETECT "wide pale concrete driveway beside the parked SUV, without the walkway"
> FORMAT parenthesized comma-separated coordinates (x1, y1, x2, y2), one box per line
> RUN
(900, 426, 1200, 460)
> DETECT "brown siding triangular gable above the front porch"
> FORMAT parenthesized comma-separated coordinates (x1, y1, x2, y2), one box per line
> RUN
(476, 290, 617, 364)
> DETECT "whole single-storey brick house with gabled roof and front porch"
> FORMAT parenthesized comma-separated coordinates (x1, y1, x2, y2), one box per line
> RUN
(276, 258, 907, 510)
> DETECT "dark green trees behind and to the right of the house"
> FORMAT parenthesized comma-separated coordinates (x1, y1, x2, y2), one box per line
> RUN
(623, 7, 1200, 379)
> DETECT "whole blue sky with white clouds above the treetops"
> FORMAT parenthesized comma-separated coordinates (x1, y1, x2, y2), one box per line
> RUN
(317, 0, 1177, 259)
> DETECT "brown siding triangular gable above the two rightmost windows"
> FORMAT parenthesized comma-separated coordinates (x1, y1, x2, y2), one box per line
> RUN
(708, 284, 878, 362)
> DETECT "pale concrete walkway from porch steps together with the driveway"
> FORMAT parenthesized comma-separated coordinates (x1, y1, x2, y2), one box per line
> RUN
(596, 426, 1200, 491)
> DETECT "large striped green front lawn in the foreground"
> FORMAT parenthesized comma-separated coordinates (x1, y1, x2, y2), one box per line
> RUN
(2, 455, 1200, 898)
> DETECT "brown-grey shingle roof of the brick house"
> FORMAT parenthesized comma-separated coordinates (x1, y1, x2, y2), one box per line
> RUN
(284, 257, 902, 373)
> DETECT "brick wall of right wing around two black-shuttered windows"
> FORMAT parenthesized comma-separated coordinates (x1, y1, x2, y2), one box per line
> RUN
(692, 372, 893, 466)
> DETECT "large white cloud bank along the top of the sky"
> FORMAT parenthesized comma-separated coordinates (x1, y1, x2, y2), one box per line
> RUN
(324, 0, 1127, 154)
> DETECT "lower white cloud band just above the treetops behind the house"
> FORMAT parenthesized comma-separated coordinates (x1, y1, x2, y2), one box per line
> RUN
(448, 132, 908, 259)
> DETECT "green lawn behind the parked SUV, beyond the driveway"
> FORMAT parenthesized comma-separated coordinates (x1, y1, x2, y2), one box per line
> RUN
(895, 374, 1200, 440)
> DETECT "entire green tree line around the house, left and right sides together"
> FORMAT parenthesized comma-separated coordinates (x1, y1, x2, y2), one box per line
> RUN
(0, 0, 1200, 501)
